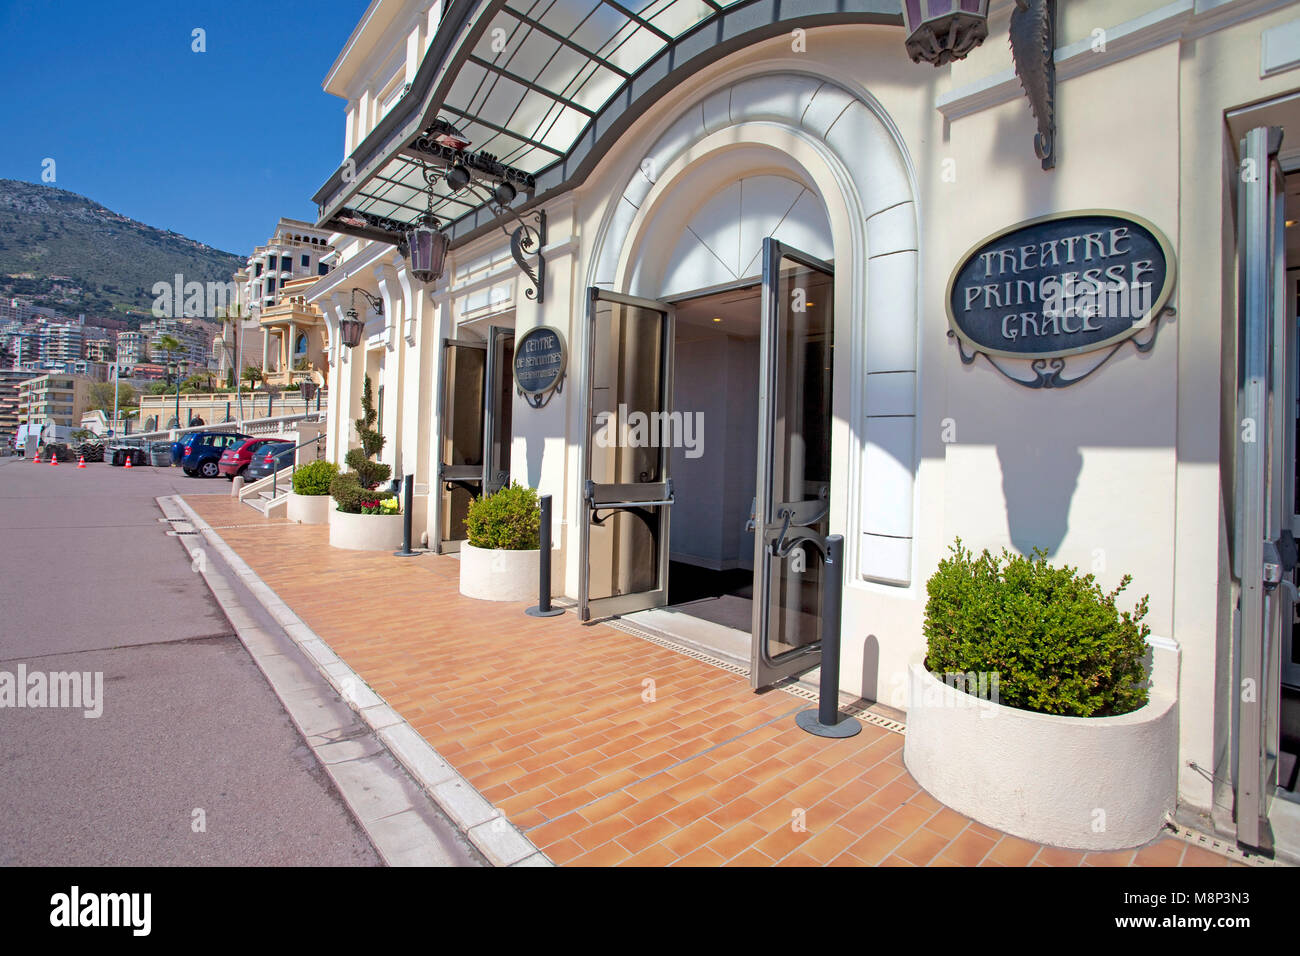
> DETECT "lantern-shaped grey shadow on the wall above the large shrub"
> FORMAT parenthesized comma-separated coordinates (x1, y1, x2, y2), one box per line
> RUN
(997, 440, 1083, 558)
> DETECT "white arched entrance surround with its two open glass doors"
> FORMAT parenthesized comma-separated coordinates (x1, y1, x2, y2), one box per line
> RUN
(579, 74, 917, 687)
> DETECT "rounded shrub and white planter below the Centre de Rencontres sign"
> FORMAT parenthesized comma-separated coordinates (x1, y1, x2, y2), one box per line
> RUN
(460, 483, 541, 601)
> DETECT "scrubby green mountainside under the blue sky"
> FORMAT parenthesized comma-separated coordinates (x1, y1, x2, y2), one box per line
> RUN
(0, 179, 244, 328)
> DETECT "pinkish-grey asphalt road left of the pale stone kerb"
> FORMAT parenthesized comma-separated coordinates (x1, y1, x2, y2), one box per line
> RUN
(0, 458, 380, 866)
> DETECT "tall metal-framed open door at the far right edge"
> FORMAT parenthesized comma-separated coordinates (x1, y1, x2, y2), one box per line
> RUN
(1232, 126, 1296, 855)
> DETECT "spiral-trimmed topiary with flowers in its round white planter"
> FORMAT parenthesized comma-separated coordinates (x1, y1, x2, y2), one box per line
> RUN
(329, 376, 402, 551)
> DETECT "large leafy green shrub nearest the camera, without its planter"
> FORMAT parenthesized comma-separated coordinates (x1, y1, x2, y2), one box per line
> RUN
(923, 538, 1151, 717)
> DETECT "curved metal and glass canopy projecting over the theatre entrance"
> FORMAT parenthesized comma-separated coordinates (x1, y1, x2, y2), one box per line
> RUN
(315, 0, 902, 251)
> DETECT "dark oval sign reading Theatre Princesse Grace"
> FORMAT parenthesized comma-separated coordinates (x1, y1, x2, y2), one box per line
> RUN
(948, 209, 1175, 359)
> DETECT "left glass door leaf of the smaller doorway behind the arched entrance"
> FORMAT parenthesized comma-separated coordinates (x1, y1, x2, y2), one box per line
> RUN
(434, 338, 488, 554)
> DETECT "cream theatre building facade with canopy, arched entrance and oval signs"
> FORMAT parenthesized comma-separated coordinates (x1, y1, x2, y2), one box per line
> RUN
(307, 0, 1300, 853)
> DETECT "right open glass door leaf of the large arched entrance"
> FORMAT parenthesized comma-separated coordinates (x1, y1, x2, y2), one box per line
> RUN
(749, 238, 835, 689)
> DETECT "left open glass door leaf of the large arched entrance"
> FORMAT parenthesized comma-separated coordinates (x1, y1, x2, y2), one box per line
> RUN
(579, 287, 672, 620)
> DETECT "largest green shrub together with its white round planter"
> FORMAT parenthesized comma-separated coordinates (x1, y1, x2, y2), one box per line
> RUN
(904, 540, 1178, 849)
